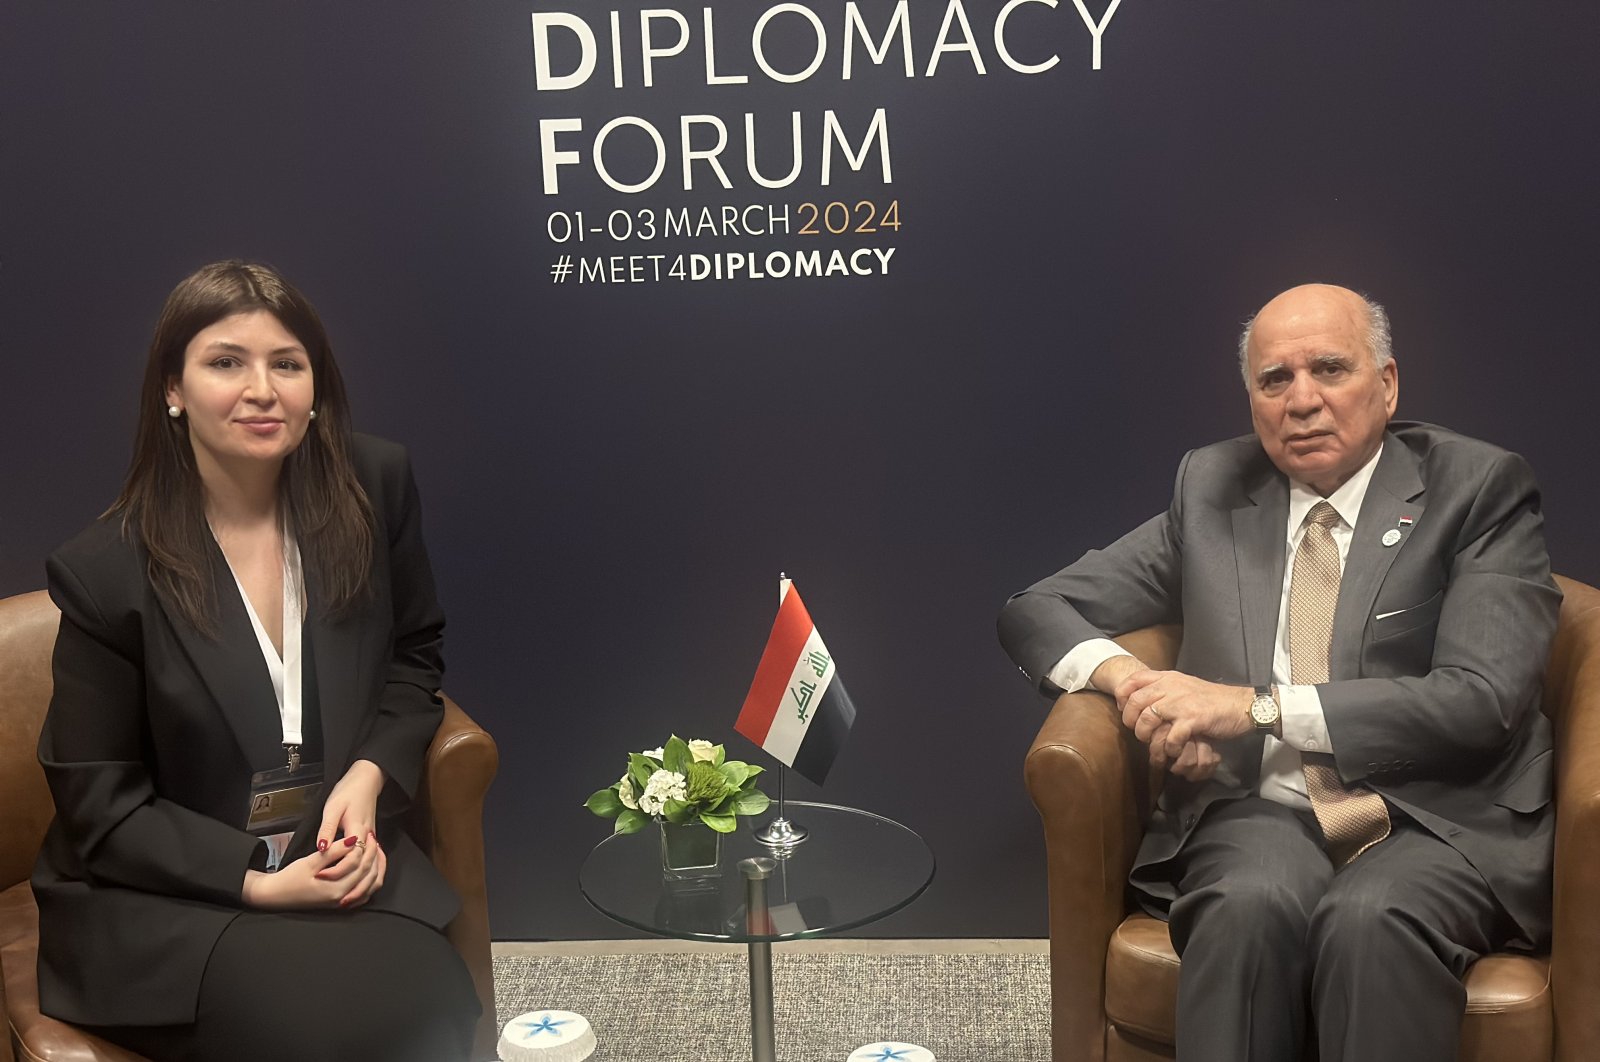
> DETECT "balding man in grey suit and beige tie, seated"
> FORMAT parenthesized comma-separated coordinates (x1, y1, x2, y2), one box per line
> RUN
(1000, 285, 1560, 1062)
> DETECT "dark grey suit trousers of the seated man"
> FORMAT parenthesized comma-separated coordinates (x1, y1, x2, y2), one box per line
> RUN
(1168, 797, 1510, 1062)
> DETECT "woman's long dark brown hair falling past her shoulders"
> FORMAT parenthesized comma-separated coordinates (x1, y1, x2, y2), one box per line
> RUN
(106, 261, 373, 633)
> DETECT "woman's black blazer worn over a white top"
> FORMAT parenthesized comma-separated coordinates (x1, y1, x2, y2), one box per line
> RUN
(32, 435, 459, 1025)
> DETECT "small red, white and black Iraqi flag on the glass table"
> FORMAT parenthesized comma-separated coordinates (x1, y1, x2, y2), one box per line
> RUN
(733, 579, 856, 785)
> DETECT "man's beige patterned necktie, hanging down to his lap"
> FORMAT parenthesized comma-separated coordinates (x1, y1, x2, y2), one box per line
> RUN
(1290, 502, 1389, 867)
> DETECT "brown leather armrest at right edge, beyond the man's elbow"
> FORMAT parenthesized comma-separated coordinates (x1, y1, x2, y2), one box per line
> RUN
(1549, 584, 1600, 1062)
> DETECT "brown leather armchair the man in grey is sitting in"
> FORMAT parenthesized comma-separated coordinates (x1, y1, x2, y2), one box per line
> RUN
(1024, 576, 1600, 1062)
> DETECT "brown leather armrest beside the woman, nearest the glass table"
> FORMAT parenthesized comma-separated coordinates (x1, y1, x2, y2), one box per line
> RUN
(411, 694, 499, 1059)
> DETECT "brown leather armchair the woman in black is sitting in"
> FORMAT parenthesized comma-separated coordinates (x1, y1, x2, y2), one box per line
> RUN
(0, 590, 499, 1062)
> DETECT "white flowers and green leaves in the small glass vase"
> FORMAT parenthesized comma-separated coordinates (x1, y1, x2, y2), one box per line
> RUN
(584, 734, 771, 833)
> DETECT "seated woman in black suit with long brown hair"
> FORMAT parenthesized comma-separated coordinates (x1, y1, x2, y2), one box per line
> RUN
(34, 262, 478, 1062)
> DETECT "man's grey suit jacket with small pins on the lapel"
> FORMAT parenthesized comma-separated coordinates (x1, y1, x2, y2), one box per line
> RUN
(1000, 421, 1560, 947)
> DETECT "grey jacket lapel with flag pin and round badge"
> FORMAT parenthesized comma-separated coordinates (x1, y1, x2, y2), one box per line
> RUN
(1328, 435, 1427, 680)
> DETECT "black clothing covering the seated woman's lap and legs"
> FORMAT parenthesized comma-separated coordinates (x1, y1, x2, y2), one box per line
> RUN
(93, 912, 480, 1062)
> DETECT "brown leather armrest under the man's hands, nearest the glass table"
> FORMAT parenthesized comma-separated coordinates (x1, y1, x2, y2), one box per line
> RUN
(1022, 691, 1142, 1062)
